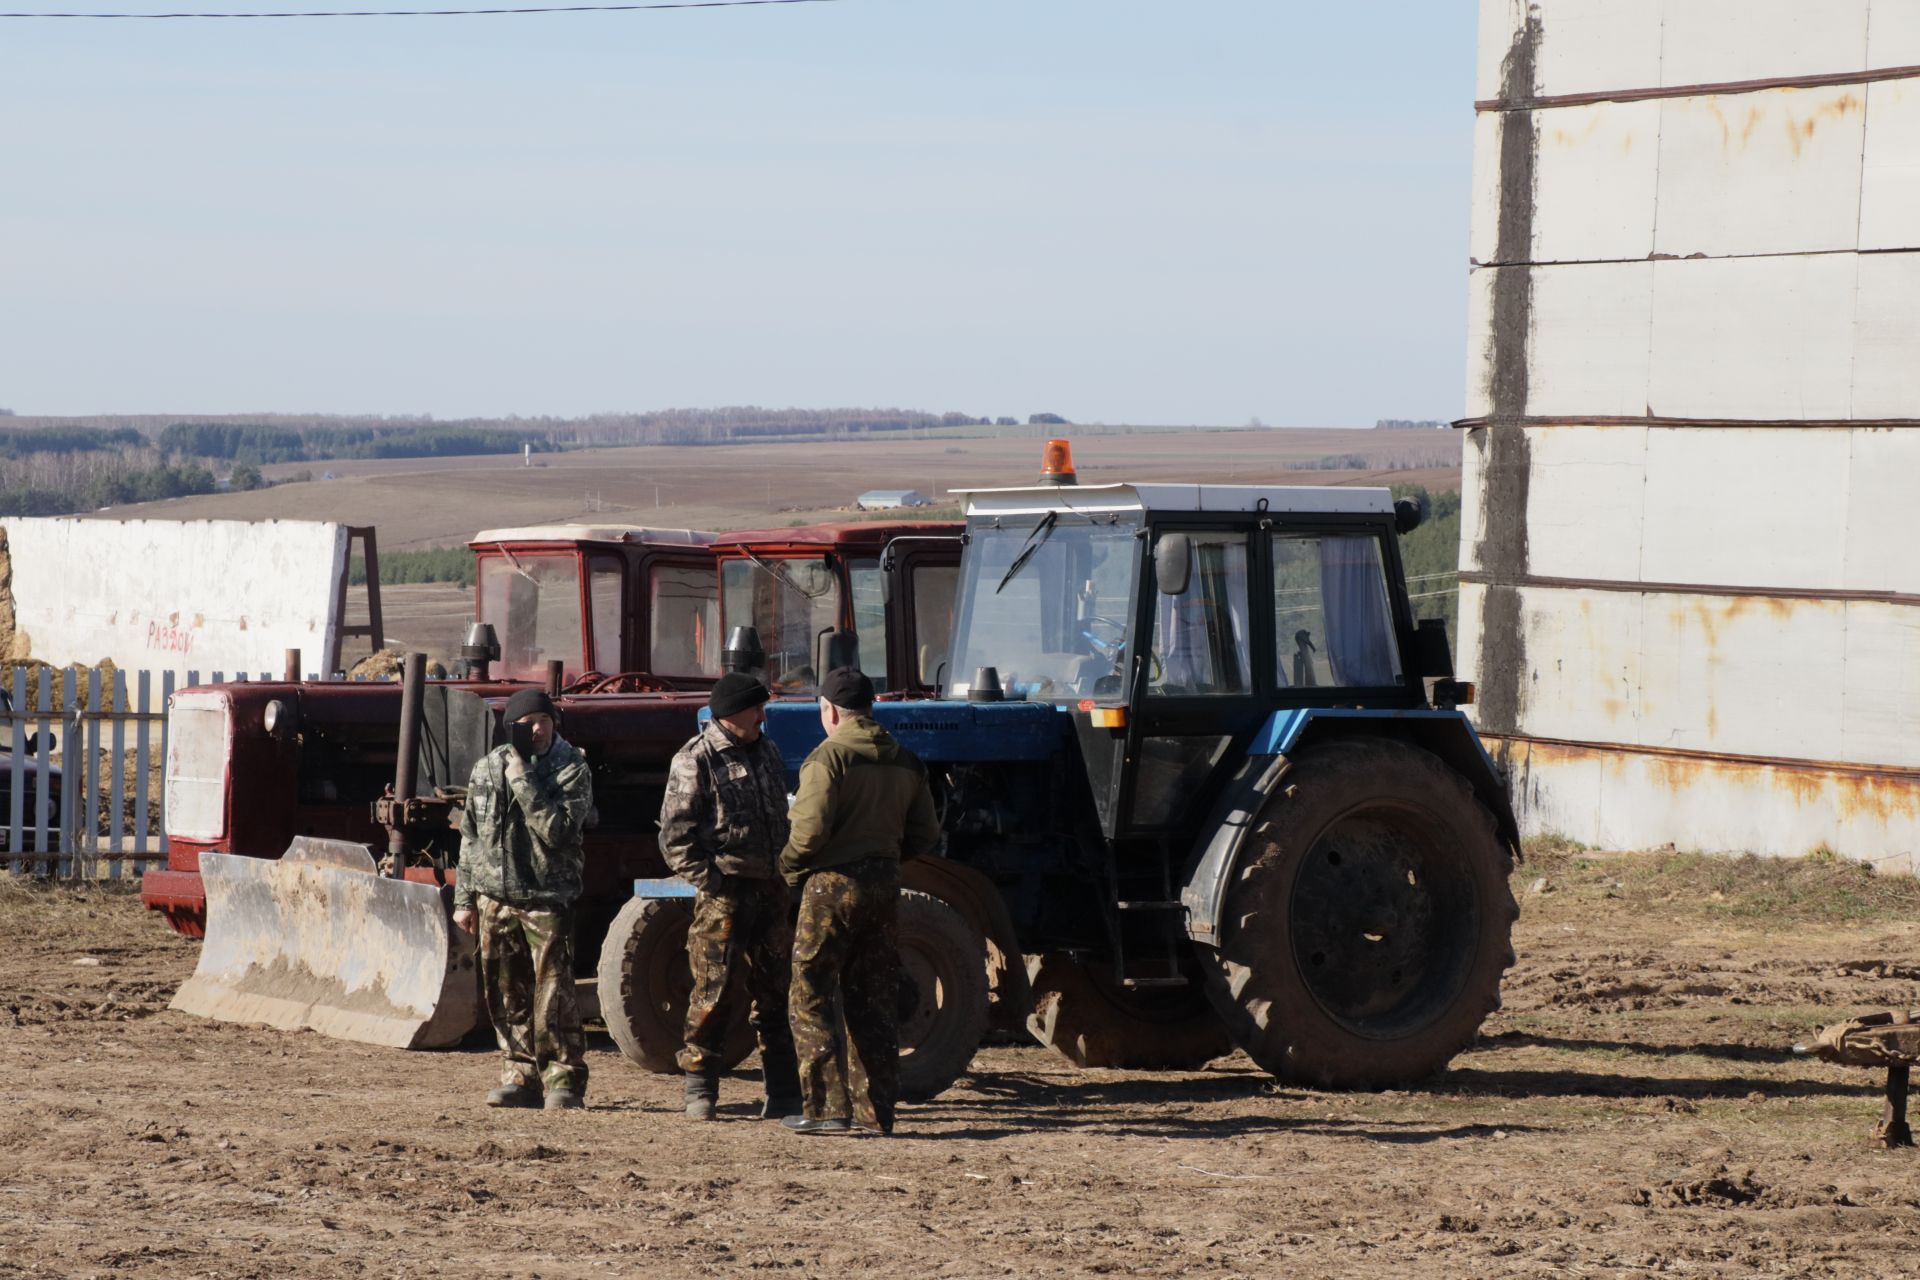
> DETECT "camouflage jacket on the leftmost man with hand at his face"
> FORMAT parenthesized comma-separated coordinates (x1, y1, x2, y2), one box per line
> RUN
(453, 737, 593, 910)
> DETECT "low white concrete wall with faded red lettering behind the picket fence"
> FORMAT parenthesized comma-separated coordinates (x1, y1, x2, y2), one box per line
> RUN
(4, 520, 348, 676)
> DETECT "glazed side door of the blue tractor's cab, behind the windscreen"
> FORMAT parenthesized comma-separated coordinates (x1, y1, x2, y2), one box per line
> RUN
(1108, 518, 1273, 837)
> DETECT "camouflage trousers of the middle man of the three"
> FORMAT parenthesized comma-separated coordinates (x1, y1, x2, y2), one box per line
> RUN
(676, 875, 797, 1098)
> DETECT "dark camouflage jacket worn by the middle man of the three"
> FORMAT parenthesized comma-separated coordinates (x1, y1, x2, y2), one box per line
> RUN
(660, 720, 787, 889)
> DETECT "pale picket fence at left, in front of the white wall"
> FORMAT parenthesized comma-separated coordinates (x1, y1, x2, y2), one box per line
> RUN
(0, 668, 349, 879)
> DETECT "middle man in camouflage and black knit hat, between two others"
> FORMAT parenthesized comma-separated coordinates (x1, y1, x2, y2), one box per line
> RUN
(660, 672, 801, 1121)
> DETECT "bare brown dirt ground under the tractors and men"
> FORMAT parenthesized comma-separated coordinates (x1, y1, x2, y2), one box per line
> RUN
(0, 848, 1920, 1278)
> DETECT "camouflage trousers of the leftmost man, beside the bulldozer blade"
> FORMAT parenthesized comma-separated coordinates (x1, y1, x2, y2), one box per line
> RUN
(474, 894, 588, 1094)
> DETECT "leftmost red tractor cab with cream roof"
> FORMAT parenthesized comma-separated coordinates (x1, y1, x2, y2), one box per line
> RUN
(468, 524, 720, 687)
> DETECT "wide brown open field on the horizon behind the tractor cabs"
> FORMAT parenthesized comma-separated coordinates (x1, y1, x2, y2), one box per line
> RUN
(108, 428, 1461, 549)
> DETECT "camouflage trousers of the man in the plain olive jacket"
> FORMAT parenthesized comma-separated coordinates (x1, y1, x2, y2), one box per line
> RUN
(789, 858, 900, 1130)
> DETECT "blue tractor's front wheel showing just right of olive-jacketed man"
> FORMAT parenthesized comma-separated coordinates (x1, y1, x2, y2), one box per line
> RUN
(899, 889, 987, 1102)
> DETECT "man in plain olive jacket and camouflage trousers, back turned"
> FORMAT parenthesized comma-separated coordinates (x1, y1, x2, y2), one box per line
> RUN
(780, 668, 941, 1134)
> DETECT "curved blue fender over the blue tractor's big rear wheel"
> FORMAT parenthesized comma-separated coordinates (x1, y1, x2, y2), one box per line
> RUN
(1181, 706, 1521, 946)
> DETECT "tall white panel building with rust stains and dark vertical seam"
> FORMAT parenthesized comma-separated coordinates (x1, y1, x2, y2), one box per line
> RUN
(1459, 0, 1920, 869)
